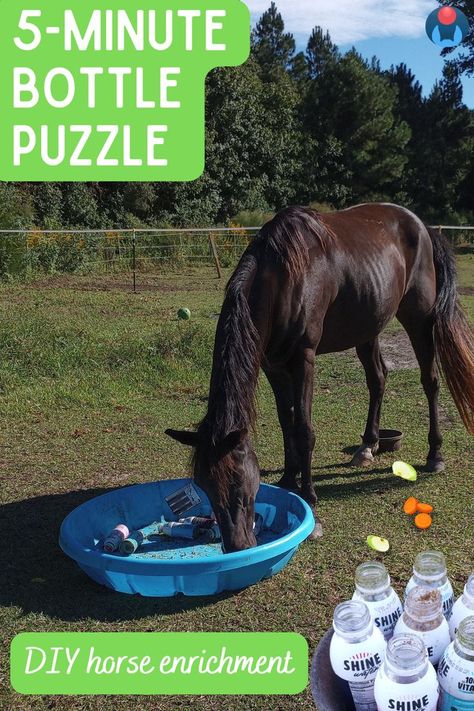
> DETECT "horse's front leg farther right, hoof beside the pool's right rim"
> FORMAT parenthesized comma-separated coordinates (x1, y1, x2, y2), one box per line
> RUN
(292, 348, 322, 538)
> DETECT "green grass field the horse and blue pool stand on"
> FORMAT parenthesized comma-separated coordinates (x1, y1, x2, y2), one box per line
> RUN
(0, 255, 474, 711)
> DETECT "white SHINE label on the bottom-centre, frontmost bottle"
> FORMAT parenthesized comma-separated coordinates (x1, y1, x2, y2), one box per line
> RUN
(375, 664, 439, 711)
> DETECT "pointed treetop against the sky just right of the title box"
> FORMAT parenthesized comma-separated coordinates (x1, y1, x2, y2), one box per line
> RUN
(252, 2, 296, 77)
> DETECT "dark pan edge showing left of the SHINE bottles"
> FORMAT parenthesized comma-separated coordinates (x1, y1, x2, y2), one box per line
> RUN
(311, 629, 355, 711)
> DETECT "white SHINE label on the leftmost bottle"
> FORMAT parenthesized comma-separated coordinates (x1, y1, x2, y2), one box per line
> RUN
(330, 628, 386, 711)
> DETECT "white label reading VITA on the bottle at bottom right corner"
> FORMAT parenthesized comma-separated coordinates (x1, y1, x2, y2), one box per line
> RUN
(438, 643, 474, 711)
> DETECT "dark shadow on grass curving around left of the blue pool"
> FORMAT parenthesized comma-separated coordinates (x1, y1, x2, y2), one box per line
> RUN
(0, 489, 237, 631)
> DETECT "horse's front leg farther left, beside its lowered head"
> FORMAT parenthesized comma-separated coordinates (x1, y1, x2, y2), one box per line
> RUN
(264, 367, 300, 489)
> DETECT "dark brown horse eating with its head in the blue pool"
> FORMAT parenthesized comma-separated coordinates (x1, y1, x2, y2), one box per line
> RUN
(167, 204, 474, 552)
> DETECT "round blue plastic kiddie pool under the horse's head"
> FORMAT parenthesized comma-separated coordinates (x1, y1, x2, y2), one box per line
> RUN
(59, 479, 314, 597)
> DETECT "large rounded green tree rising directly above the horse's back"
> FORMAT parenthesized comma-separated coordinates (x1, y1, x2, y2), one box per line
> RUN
(306, 50, 410, 201)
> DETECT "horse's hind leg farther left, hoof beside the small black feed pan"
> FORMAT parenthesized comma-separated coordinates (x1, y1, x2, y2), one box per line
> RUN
(351, 338, 388, 467)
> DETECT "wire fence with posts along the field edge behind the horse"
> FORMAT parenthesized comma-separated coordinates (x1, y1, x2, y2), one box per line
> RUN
(0, 225, 474, 292)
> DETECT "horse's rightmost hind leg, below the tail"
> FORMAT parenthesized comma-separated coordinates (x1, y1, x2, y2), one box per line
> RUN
(397, 310, 445, 472)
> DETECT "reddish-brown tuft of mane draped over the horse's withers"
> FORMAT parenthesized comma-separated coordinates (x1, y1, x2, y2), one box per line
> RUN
(259, 207, 332, 281)
